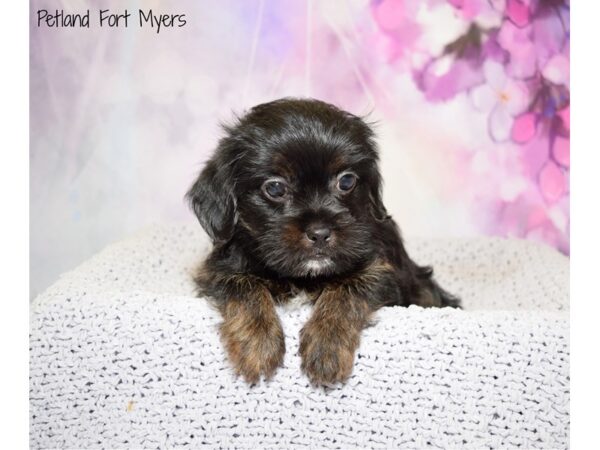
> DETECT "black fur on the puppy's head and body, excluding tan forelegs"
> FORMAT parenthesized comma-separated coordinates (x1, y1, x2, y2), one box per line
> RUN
(187, 99, 459, 381)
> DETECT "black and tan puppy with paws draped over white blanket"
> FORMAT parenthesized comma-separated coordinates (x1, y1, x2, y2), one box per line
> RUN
(187, 99, 459, 385)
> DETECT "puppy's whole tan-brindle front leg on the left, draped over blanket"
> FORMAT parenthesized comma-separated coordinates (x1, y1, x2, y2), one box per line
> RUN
(220, 277, 285, 383)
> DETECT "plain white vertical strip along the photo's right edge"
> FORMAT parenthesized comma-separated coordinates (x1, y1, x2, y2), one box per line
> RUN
(571, 1, 600, 448)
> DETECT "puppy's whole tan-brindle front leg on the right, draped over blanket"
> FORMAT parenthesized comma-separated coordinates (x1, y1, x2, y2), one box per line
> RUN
(300, 286, 372, 384)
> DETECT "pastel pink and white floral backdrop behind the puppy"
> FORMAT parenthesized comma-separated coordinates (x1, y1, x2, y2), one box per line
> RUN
(30, 0, 570, 295)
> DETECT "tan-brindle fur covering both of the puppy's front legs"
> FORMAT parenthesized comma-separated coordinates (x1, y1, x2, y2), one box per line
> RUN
(202, 260, 398, 385)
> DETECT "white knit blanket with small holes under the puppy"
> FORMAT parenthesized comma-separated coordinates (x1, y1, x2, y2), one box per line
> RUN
(30, 225, 569, 449)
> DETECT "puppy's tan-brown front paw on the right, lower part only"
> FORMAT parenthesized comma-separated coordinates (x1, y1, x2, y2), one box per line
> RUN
(300, 321, 359, 385)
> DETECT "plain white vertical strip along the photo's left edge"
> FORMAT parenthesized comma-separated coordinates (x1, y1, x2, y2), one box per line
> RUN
(0, 2, 29, 449)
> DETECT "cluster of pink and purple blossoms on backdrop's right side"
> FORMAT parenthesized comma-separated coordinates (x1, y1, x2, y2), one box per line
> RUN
(373, 0, 570, 253)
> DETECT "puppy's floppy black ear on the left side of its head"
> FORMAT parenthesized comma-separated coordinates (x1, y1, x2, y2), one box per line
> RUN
(186, 159, 237, 244)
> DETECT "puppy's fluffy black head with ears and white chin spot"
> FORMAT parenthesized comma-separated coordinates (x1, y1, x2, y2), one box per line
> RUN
(187, 99, 387, 277)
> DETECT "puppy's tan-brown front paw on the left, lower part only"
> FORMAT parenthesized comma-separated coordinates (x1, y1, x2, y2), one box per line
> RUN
(221, 312, 285, 383)
